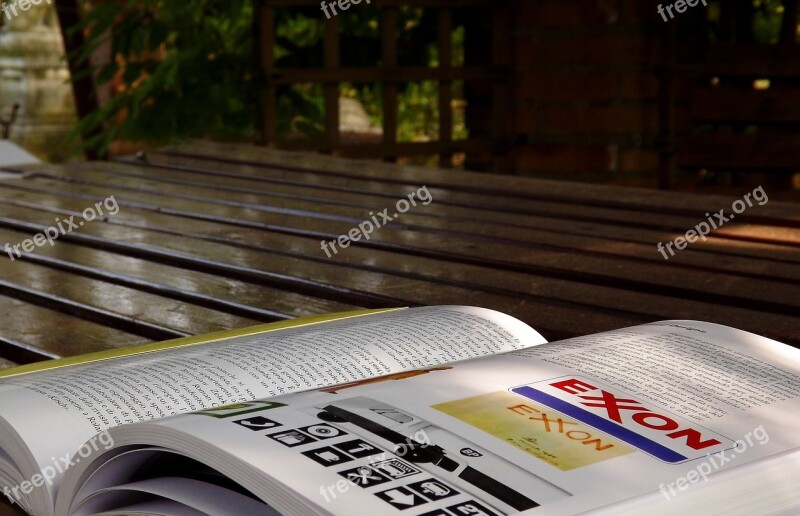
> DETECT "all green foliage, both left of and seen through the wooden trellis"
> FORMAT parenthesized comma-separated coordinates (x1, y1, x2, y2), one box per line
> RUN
(71, 0, 466, 154)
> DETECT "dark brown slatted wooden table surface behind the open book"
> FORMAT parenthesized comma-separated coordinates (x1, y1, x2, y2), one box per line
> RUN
(0, 142, 800, 367)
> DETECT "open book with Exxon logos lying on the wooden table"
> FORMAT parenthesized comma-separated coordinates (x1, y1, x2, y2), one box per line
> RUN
(0, 306, 800, 516)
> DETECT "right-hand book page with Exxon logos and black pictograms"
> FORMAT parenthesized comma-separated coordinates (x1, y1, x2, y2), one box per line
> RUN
(64, 321, 800, 516)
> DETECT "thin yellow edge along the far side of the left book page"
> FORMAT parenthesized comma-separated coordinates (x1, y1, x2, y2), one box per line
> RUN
(0, 308, 405, 379)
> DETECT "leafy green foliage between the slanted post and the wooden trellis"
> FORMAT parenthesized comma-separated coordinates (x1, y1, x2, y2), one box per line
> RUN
(71, 0, 260, 157)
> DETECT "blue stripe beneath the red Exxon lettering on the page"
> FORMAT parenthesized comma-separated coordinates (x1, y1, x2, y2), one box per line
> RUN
(511, 386, 688, 462)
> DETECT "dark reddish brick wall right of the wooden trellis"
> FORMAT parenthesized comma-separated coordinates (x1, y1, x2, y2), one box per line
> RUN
(508, 0, 661, 186)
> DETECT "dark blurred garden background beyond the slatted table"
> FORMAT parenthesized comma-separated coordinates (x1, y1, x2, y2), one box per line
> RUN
(0, 0, 800, 201)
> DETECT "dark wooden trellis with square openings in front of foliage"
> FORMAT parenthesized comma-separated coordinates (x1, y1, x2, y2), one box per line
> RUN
(258, 0, 510, 167)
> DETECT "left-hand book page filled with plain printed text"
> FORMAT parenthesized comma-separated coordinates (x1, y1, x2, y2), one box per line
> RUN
(0, 307, 544, 510)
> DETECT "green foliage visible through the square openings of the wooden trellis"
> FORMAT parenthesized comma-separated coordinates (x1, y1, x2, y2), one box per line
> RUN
(276, 7, 467, 145)
